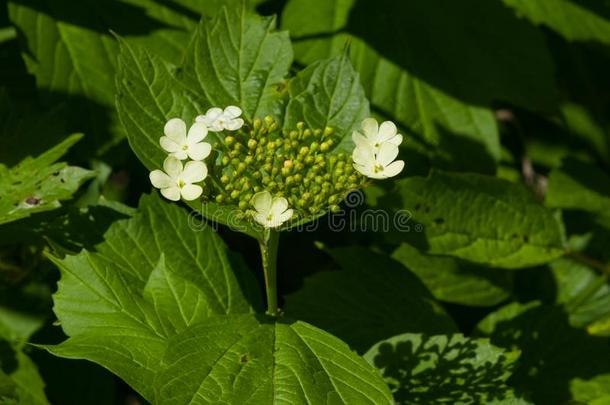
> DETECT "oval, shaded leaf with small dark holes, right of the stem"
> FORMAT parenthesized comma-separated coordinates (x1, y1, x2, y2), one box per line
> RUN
(381, 172, 564, 269)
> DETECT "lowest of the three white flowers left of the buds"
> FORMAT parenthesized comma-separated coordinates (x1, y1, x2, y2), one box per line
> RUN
(149, 156, 208, 201)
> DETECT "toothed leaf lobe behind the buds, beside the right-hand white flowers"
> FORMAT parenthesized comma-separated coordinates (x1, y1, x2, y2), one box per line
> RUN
(284, 55, 369, 152)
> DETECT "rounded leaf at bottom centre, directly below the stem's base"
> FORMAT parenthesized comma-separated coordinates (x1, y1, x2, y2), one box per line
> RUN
(155, 316, 392, 404)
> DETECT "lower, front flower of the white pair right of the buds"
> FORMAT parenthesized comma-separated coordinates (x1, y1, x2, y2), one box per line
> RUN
(352, 142, 405, 179)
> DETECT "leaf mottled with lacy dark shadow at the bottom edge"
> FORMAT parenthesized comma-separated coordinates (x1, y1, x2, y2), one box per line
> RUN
(364, 333, 526, 404)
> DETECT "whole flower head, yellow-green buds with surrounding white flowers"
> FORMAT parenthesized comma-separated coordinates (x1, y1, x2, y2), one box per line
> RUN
(150, 106, 404, 228)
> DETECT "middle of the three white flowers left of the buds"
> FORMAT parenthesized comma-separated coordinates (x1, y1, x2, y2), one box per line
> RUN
(159, 118, 212, 160)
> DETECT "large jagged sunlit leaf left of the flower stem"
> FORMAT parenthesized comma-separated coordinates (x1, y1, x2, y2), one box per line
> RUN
(43, 196, 260, 393)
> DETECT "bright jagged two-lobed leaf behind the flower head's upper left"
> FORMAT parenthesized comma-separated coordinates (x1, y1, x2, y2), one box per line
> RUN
(117, 4, 292, 238)
